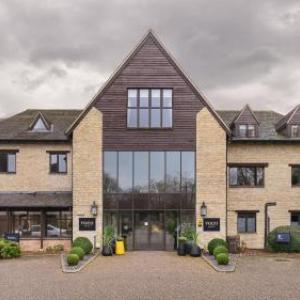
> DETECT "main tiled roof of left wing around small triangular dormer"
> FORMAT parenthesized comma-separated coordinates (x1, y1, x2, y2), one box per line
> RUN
(0, 109, 81, 141)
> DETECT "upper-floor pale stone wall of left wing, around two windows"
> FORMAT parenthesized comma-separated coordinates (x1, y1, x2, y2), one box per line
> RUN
(0, 143, 72, 192)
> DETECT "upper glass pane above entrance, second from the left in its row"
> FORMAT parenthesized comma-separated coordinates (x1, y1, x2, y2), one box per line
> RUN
(119, 151, 132, 192)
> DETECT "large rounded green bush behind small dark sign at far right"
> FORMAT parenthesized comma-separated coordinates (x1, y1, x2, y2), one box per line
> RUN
(267, 226, 300, 252)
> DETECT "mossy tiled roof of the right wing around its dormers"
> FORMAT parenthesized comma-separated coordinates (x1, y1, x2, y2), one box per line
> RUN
(218, 110, 290, 141)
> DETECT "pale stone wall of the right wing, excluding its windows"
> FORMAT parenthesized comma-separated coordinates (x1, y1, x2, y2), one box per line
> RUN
(228, 143, 300, 248)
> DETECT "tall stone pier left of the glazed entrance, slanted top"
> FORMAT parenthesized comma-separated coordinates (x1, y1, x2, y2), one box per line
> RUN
(73, 108, 103, 247)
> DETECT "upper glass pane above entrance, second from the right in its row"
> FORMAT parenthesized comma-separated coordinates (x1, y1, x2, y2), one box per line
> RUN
(166, 151, 180, 192)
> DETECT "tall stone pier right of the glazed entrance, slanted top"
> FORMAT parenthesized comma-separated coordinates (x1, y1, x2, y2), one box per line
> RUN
(196, 108, 226, 245)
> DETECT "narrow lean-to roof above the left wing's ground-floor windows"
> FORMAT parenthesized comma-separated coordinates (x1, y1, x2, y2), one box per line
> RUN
(0, 192, 72, 208)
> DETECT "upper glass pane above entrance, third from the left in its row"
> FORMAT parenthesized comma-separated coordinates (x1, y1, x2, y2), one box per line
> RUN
(134, 151, 149, 192)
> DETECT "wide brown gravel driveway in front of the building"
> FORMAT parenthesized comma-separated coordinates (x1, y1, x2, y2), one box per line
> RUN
(0, 252, 300, 300)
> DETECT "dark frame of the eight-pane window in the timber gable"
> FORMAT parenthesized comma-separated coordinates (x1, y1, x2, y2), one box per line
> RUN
(126, 87, 174, 130)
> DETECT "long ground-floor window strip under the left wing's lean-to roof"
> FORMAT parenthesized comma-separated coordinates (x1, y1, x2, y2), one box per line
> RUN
(0, 209, 72, 238)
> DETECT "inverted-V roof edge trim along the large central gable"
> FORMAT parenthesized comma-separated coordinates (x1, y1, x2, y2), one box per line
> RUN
(66, 30, 230, 134)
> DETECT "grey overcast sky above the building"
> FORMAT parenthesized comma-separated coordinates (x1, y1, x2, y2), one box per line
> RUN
(0, 0, 300, 117)
